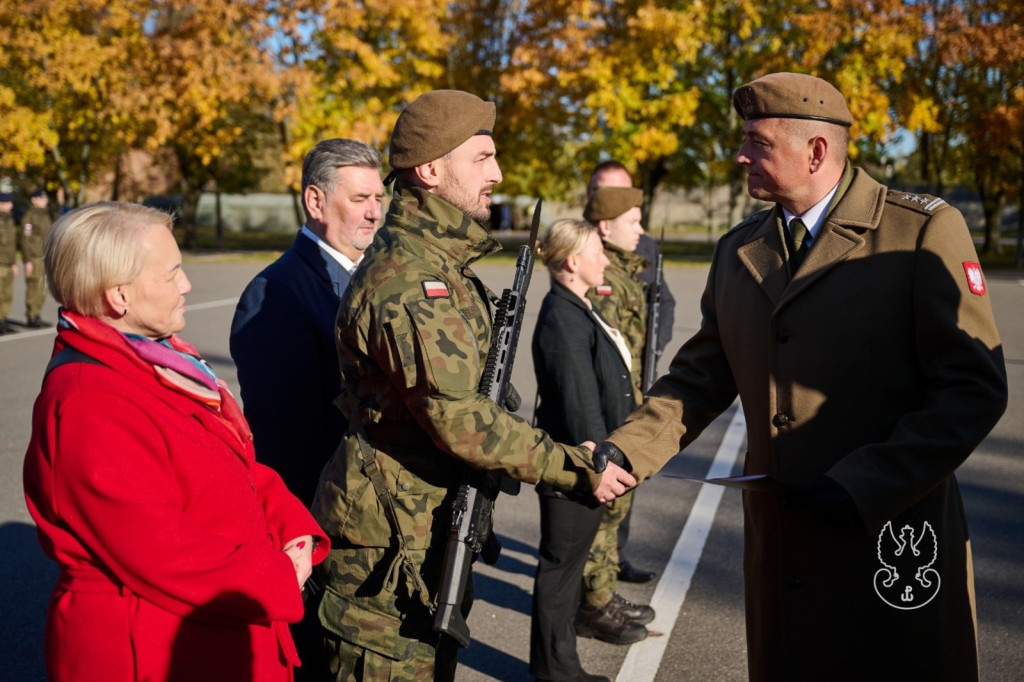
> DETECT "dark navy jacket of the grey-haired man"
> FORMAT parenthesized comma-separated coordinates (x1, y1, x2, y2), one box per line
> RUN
(230, 233, 349, 505)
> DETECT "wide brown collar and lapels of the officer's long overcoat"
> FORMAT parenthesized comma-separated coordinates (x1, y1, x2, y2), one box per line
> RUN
(736, 168, 886, 306)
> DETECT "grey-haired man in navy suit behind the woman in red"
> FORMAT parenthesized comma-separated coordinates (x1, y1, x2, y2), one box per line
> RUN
(230, 139, 384, 505)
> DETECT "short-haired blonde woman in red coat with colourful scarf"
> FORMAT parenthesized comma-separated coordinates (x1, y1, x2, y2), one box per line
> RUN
(25, 203, 328, 682)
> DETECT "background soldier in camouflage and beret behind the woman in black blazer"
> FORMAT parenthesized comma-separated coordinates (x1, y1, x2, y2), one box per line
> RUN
(577, 187, 654, 644)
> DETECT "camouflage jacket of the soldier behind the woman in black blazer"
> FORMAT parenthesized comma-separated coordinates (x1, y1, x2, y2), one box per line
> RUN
(587, 243, 647, 395)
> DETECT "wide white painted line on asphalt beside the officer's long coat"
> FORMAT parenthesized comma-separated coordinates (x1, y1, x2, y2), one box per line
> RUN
(615, 406, 746, 682)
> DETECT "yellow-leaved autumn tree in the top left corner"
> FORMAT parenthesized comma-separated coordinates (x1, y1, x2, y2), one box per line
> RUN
(0, 0, 150, 205)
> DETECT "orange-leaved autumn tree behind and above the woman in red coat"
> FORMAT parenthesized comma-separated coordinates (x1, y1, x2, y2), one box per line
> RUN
(136, 0, 278, 247)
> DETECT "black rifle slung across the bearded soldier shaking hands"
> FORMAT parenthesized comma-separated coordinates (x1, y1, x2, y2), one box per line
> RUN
(433, 200, 541, 646)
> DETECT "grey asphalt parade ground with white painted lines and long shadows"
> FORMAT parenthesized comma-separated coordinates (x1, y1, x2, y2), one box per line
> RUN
(0, 251, 1024, 682)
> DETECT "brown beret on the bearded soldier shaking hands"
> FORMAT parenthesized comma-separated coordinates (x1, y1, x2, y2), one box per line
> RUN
(388, 90, 495, 169)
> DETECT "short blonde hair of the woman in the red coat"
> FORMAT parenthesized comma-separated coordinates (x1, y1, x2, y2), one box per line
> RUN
(43, 202, 173, 317)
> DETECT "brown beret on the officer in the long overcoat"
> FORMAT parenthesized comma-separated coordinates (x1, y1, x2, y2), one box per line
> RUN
(732, 73, 853, 127)
